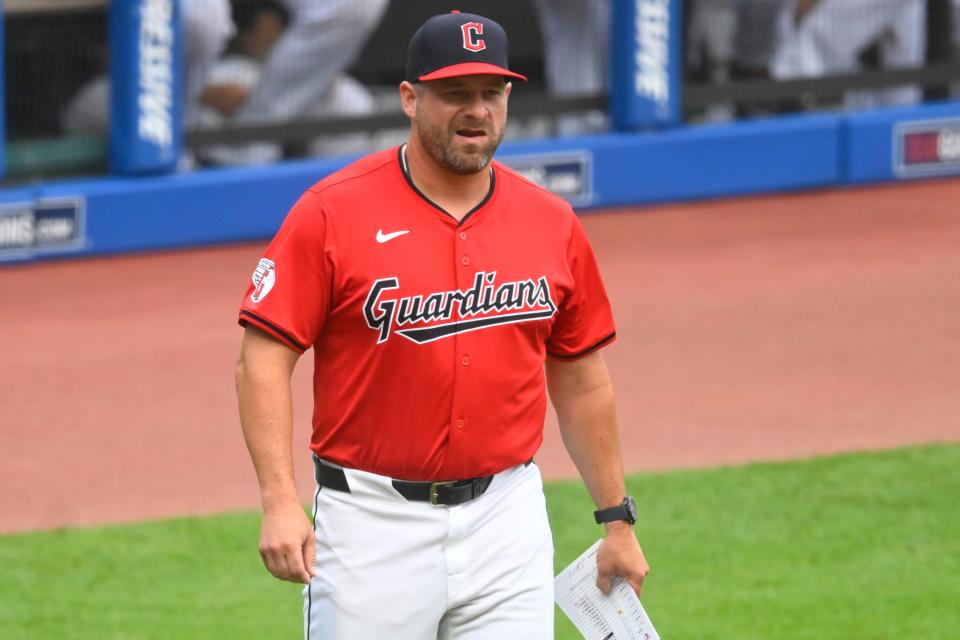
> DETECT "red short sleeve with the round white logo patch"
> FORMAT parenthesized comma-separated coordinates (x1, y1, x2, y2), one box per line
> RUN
(239, 191, 334, 353)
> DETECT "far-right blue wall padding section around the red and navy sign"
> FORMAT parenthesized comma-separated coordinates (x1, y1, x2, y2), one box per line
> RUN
(847, 102, 960, 183)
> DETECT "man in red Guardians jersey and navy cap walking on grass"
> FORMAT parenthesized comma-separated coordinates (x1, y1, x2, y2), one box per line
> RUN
(237, 12, 648, 640)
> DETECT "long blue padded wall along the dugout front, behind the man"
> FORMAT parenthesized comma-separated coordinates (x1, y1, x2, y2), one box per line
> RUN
(0, 103, 960, 262)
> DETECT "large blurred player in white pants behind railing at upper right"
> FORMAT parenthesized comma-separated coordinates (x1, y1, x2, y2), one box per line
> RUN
(771, 0, 926, 108)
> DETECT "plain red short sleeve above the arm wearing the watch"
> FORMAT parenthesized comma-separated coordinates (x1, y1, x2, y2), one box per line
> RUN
(547, 216, 617, 360)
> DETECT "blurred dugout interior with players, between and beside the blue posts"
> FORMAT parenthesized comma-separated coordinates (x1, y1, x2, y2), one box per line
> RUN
(3, 0, 960, 183)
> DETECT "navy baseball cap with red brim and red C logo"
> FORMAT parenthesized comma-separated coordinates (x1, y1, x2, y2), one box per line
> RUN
(406, 11, 526, 82)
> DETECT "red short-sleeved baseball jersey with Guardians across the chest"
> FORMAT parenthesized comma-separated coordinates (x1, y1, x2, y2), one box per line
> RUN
(240, 147, 616, 480)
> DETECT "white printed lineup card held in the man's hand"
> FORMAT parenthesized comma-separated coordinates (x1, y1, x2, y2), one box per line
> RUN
(554, 540, 660, 640)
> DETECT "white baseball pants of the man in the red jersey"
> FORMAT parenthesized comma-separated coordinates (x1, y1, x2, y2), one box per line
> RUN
(304, 464, 554, 640)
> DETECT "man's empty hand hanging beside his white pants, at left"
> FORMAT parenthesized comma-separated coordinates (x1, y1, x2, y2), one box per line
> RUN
(260, 501, 317, 584)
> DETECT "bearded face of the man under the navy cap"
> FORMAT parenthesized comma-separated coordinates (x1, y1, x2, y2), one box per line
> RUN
(414, 75, 511, 175)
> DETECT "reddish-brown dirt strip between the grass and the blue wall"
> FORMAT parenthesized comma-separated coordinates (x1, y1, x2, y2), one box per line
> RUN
(0, 180, 960, 532)
